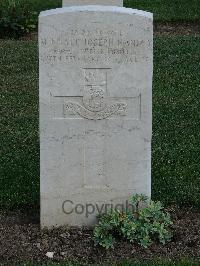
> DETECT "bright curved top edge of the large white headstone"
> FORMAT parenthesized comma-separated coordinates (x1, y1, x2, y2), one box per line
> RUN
(39, 5, 153, 20)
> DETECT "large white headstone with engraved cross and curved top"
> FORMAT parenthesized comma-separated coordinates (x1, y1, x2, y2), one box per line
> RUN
(39, 6, 153, 227)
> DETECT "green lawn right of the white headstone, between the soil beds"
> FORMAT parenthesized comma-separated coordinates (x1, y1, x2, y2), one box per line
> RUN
(152, 37, 200, 208)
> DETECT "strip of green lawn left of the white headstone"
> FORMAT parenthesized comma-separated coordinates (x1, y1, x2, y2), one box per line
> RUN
(0, 41, 39, 208)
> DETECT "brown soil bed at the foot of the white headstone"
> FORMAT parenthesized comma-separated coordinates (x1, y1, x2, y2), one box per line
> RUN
(0, 207, 200, 265)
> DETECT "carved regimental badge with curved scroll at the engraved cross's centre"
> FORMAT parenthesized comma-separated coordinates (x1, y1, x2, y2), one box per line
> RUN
(65, 68, 127, 120)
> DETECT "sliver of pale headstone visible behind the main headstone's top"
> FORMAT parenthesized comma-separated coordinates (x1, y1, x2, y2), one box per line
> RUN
(63, 0, 123, 6)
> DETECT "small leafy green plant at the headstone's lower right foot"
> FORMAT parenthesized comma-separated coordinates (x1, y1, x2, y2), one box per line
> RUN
(93, 194, 172, 249)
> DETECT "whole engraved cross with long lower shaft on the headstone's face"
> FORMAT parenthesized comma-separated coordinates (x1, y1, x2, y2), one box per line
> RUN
(51, 68, 141, 189)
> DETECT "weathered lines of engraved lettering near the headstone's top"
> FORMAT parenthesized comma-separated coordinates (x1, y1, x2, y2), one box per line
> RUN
(40, 29, 152, 64)
